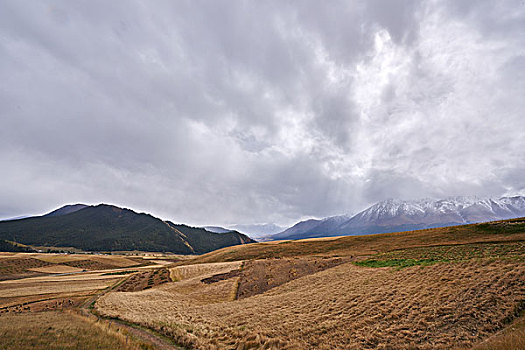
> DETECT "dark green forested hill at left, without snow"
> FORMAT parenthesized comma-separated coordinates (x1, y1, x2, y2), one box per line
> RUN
(0, 204, 253, 254)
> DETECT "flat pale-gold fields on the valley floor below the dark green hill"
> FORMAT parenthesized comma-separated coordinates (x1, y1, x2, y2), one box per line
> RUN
(0, 253, 162, 312)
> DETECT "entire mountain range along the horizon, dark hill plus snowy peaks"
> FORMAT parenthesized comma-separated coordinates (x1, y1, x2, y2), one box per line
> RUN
(0, 196, 525, 250)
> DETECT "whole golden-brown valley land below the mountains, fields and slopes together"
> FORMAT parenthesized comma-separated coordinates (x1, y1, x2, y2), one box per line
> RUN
(0, 219, 525, 349)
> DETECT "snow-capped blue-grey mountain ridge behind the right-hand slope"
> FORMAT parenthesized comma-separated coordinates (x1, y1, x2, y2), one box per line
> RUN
(272, 196, 525, 239)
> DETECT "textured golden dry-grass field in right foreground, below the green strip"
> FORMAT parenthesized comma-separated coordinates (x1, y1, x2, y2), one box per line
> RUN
(97, 261, 525, 349)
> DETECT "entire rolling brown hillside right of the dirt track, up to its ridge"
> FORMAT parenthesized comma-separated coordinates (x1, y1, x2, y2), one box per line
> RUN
(95, 220, 525, 349)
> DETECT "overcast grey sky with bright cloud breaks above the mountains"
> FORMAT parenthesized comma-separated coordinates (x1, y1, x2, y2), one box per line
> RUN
(0, 0, 525, 225)
